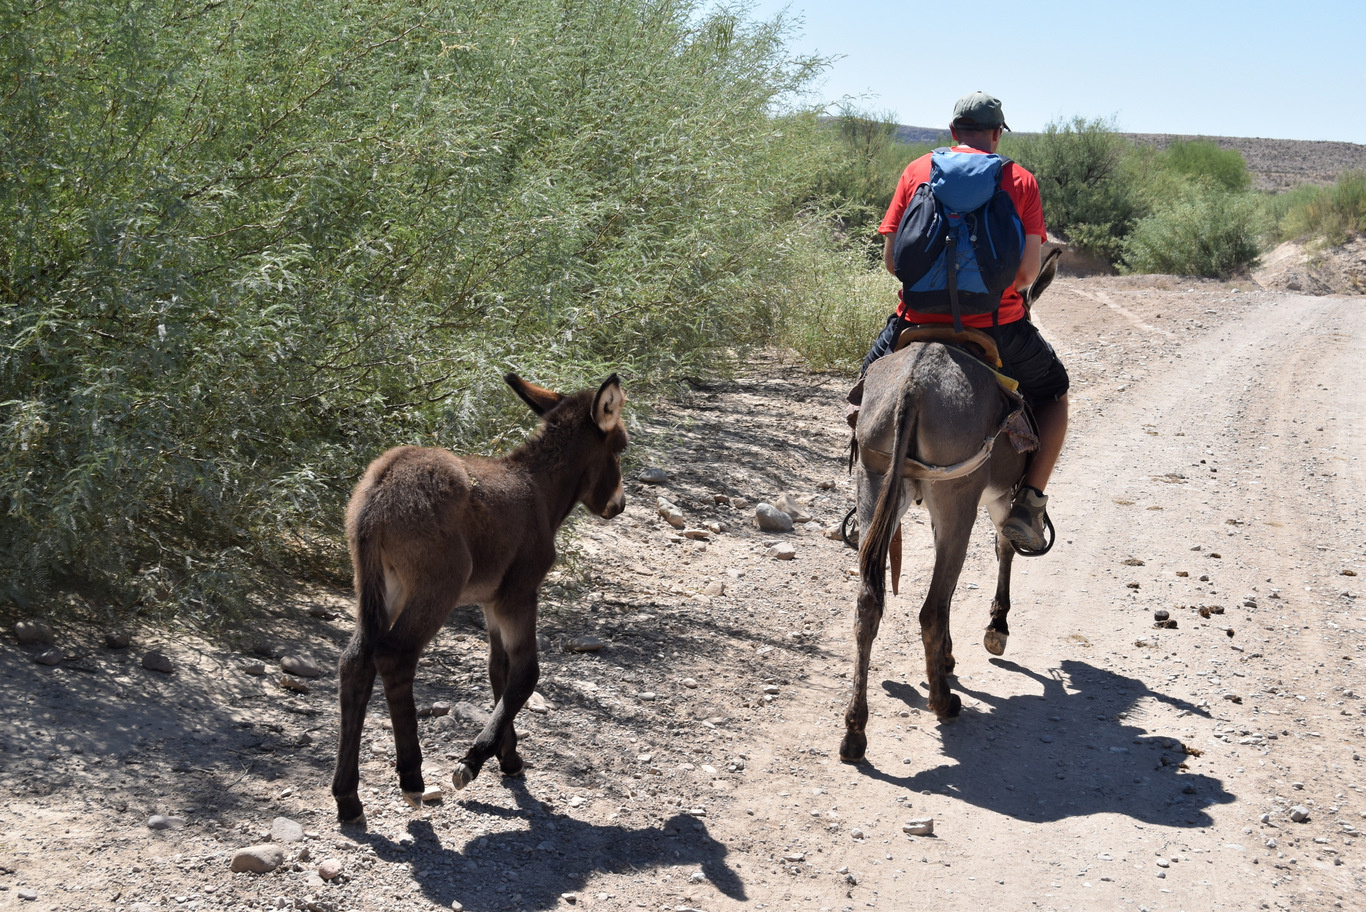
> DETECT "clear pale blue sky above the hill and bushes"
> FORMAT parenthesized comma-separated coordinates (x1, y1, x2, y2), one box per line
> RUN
(750, 0, 1366, 143)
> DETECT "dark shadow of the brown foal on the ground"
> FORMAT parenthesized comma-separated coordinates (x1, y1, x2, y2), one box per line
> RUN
(352, 778, 749, 912)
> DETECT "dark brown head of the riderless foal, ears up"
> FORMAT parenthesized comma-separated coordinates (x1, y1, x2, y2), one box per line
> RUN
(504, 374, 627, 519)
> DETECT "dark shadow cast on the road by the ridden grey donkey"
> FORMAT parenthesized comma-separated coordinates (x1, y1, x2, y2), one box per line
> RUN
(858, 658, 1235, 827)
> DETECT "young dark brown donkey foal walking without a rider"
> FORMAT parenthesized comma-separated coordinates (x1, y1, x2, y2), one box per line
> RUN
(332, 374, 627, 823)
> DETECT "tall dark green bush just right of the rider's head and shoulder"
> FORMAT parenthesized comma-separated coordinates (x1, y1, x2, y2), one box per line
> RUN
(1001, 117, 1146, 262)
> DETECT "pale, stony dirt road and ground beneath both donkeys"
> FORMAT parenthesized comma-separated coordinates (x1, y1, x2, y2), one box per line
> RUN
(0, 277, 1366, 912)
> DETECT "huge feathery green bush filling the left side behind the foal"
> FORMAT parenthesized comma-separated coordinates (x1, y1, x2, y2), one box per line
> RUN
(0, 0, 822, 620)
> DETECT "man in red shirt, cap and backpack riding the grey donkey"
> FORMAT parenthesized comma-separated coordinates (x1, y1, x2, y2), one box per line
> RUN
(848, 91, 1068, 554)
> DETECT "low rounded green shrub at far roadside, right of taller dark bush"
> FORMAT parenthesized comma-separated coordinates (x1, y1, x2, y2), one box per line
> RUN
(1121, 183, 1266, 279)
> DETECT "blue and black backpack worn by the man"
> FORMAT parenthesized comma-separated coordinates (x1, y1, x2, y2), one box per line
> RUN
(892, 149, 1025, 332)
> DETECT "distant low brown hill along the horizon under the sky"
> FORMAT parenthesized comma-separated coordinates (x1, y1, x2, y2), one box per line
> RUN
(896, 126, 1366, 191)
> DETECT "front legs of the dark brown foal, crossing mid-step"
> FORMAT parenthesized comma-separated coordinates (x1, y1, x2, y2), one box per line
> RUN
(451, 599, 541, 789)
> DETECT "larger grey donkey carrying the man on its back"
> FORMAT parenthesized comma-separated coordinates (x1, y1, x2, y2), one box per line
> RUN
(840, 250, 1059, 763)
